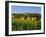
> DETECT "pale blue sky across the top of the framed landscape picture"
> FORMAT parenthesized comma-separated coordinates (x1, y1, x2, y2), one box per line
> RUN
(11, 5, 41, 14)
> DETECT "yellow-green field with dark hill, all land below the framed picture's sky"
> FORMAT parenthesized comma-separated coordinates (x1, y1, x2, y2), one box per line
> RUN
(12, 13, 41, 31)
